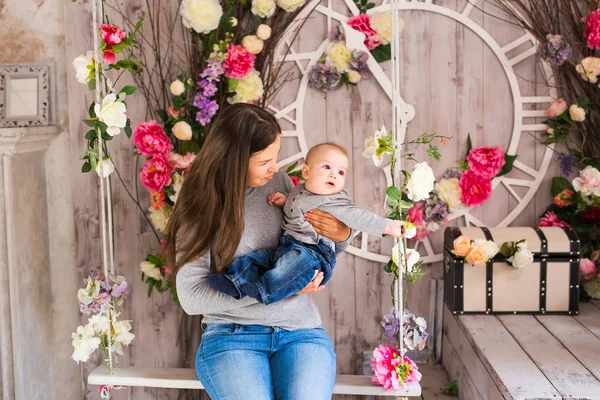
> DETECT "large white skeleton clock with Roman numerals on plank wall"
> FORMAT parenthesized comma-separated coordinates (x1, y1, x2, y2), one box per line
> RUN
(269, 0, 556, 263)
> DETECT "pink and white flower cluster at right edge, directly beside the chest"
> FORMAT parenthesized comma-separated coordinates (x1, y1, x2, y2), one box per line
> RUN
(539, 165, 600, 300)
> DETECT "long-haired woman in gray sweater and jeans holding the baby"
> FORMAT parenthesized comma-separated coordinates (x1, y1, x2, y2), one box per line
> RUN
(166, 104, 351, 400)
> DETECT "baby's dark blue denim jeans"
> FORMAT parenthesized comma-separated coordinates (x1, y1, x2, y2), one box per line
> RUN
(208, 235, 335, 304)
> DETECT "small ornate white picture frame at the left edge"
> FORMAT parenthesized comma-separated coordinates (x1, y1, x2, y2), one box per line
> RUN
(0, 65, 50, 128)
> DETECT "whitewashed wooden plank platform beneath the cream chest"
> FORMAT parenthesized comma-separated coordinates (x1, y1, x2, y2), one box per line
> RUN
(442, 301, 600, 400)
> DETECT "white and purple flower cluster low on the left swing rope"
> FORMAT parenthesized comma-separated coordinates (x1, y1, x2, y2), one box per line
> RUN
(71, 276, 135, 373)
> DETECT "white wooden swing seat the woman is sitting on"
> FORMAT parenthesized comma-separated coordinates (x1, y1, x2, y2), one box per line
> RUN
(88, 365, 421, 397)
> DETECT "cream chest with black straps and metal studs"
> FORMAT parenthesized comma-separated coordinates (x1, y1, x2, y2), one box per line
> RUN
(444, 227, 581, 315)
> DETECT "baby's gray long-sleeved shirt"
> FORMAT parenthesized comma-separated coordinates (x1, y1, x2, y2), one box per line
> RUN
(282, 184, 392, 245)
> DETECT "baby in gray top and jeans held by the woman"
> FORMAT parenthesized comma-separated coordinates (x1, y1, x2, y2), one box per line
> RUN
(208, 143, 405, 304)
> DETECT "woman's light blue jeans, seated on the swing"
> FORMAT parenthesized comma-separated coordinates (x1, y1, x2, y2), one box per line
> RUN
(196, 324, 335, 400)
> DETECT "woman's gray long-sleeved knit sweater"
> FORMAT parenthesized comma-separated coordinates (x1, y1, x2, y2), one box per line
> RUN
(177, 172, 352, 330)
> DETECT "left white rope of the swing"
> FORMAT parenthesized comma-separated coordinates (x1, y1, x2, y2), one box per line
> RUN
(92, 0, 114, 376)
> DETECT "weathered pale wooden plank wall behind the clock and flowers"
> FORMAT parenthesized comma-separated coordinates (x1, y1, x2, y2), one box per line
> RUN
(64, 0, 556, 399)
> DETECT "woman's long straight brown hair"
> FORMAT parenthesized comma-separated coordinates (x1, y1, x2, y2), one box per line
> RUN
(164, 103, 281, 277)
